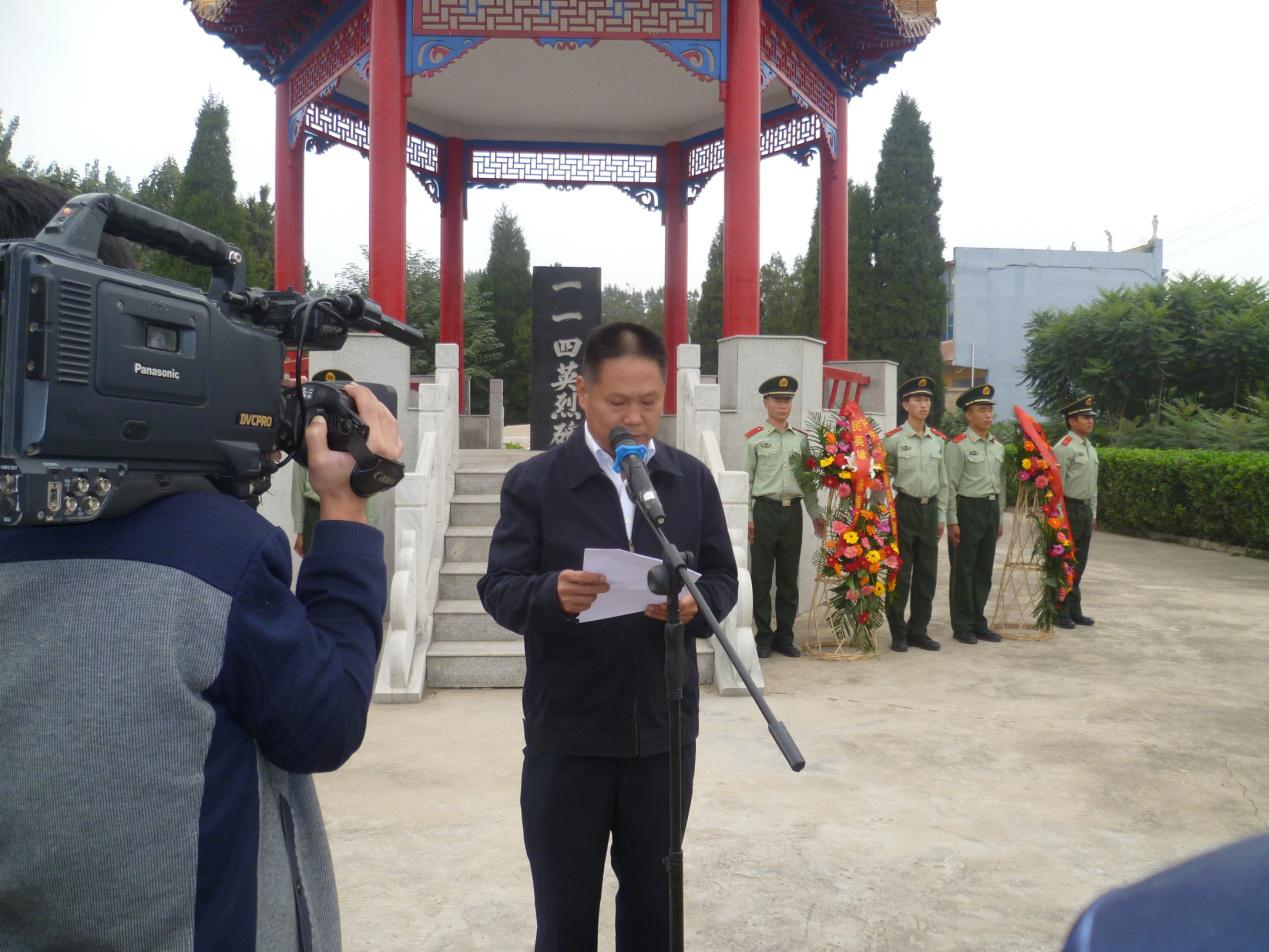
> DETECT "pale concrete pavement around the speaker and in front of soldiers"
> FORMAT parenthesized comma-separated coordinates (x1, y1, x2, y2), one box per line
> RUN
(319, 522, 1269, 952)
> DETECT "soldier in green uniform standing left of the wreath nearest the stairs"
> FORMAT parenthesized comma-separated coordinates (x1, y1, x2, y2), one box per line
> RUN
(745, 376, 824, 658)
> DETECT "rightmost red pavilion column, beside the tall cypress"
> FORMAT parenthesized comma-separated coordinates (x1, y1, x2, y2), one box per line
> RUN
(820, 95, 850, 360)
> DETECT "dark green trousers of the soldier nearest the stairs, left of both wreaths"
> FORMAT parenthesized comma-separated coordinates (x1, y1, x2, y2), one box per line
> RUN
(749, 496, 802, 646)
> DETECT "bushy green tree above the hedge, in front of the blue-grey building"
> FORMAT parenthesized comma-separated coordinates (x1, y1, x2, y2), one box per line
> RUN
(1022, 274, 1269, 423)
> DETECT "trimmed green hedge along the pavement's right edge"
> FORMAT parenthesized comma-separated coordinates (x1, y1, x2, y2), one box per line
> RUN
(1098, 447, 1269, 550)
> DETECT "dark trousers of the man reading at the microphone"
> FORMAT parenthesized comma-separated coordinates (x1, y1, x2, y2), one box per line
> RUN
(520, 741, 697, 952)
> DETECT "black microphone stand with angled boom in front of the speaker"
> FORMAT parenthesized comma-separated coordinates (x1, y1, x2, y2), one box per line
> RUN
(626, 492, 806, 952)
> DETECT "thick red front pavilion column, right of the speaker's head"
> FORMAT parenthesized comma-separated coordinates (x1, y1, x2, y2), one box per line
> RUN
(722, 0, 763, 336)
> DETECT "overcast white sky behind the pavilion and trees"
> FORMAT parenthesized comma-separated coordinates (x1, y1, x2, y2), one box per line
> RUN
(0, 0, 1269, 288)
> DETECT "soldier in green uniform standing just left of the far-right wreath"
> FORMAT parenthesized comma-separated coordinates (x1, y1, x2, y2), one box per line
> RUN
(945, 383, 1005, 645)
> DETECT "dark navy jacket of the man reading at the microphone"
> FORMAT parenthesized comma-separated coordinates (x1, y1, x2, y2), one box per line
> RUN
(477, 428, 737, 757)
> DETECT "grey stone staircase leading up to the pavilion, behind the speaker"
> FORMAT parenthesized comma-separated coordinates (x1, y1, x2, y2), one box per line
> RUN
(426, 449, 714, 688)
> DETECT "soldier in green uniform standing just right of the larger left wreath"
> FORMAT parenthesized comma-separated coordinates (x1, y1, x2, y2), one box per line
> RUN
(882, 377, 948, 651)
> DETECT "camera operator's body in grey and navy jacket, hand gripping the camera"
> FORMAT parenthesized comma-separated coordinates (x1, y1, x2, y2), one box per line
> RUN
(0, 385, 402, 952)
